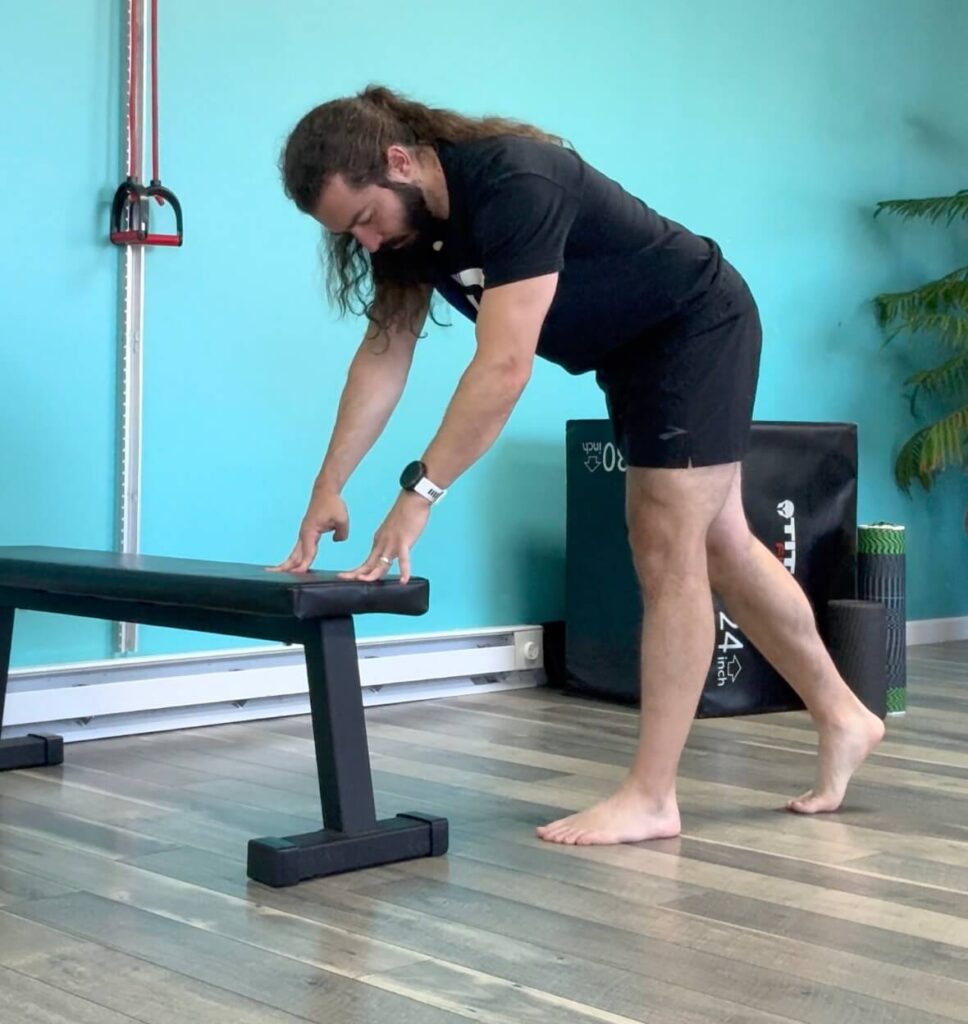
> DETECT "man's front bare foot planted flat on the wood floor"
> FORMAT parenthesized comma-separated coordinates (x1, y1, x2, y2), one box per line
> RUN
(536, 784, 681, 846)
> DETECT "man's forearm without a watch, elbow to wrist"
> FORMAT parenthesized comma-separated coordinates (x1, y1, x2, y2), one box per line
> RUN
(315, 354, 407, 494)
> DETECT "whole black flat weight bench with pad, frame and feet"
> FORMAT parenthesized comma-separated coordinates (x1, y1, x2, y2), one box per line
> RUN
(0, 546, 448, 886)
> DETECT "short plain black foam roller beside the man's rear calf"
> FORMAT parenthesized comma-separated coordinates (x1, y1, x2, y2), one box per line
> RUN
(827, 599, 887, 718)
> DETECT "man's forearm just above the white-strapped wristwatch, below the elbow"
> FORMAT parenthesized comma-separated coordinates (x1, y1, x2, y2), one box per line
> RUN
(423, 358, 528, 487)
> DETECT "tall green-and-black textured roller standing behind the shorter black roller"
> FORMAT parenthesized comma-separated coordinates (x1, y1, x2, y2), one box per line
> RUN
(857, 522, 908, 715)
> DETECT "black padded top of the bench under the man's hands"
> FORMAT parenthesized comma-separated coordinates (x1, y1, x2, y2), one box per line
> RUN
(0, 546, 430, 620)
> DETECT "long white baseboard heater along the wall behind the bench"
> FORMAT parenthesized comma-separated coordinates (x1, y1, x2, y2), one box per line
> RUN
(3, 626, 545, 742)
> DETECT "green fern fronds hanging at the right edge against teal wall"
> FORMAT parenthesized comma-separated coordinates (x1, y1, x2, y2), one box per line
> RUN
(874, 189, 968, 529)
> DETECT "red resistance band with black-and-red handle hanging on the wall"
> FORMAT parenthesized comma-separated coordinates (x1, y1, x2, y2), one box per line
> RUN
(111, 0, 182, 246)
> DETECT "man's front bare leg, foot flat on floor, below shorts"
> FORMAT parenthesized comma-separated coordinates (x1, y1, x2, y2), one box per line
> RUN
(538, 464, 739, 845)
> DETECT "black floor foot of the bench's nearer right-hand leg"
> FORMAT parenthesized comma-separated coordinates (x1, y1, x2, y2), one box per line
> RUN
(248, 813, 448, 888)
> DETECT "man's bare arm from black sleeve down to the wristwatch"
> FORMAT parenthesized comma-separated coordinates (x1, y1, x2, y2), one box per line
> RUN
(423, 273, 558, 487)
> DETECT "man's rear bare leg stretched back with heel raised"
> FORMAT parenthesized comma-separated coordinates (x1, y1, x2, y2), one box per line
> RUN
(707, 466, 884, 814)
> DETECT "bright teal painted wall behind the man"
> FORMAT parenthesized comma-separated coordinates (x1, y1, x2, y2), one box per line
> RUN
(0, 0, 968, 665)
